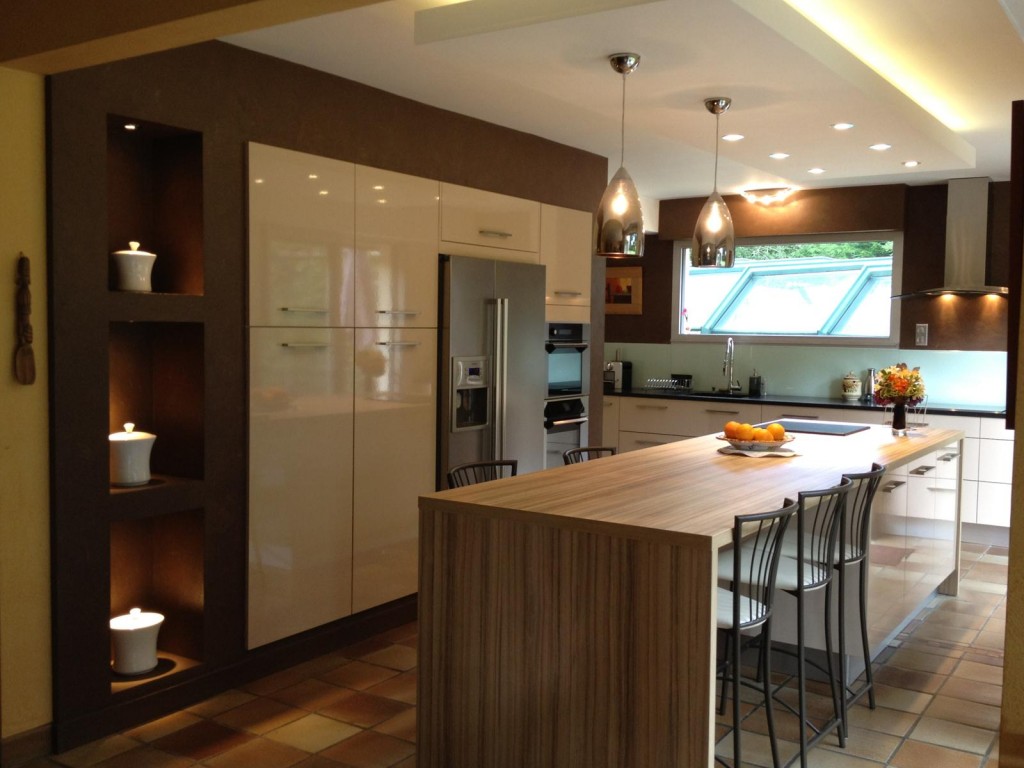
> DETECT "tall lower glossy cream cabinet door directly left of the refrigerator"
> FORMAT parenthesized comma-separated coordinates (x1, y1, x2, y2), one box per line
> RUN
(352, 329, 437, 612)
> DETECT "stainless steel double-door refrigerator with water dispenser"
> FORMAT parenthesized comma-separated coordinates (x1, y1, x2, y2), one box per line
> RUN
(437, 255, 548, 487)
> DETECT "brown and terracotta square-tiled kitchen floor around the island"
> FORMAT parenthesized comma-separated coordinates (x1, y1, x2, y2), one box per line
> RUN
(29, 545, 1007, 768)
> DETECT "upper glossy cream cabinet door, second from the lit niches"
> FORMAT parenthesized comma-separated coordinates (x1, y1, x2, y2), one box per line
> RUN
(355, 166, 439, 328)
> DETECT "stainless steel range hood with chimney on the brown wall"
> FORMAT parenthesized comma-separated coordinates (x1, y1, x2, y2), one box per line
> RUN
(893, 178, 1009, 299)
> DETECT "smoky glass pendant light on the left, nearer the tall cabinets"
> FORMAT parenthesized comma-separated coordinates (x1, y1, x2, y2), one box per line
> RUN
(595, 53, 643, 259)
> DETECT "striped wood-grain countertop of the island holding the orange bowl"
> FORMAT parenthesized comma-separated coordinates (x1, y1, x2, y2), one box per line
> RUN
(420, 426, 964, 548)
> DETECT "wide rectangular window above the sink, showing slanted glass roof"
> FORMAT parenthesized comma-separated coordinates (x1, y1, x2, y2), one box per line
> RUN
(675, 232, 902, 344)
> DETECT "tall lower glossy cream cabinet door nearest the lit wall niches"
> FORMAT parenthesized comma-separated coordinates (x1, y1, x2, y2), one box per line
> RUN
(248, 328, 353, 648)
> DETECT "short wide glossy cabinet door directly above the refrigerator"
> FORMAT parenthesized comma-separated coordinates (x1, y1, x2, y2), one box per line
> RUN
(440, 182, 541, 263)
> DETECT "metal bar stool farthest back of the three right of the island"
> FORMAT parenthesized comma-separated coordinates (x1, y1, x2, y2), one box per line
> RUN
(839, 464, 886, 732)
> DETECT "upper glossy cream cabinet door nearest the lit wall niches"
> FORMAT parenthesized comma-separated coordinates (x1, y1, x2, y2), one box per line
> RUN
(249, 142, 355, 328)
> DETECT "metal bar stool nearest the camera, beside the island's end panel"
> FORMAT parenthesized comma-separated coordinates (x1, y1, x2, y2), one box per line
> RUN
(715, 499, 798, 768)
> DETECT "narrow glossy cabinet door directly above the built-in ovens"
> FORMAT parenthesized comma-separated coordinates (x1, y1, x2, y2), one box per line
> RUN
(541, 205, 594, 323)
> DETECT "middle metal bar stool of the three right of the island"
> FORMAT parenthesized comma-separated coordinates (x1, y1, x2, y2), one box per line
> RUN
(770, 477, 853, 768)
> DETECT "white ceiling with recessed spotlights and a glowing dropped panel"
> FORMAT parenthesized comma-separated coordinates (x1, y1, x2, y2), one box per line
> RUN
(226, 0, 1024, 219)
